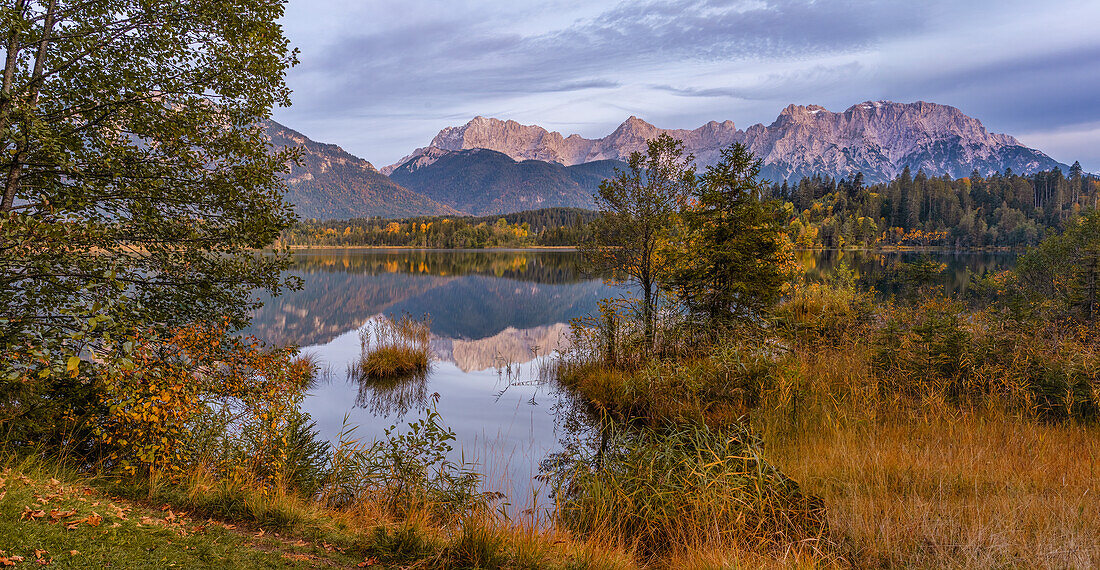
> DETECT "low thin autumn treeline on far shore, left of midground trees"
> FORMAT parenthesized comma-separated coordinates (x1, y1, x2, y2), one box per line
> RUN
(283, 208, 598, 249)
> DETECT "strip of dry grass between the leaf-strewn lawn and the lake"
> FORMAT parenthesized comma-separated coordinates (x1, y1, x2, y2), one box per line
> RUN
(102, 459, 637, 570)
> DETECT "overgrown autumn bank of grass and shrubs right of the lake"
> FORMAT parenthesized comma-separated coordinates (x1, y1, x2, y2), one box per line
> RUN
(559, 272, 1100, 568)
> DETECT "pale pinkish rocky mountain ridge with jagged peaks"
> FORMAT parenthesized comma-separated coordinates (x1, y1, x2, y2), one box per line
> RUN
(383, 101, 1068, 182)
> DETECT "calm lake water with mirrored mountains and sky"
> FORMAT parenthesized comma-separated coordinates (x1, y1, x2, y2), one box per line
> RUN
(251, 250, 1015, 507)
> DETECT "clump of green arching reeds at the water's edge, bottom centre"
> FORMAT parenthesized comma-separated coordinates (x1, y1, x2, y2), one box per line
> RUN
(556, 425, 827, 562)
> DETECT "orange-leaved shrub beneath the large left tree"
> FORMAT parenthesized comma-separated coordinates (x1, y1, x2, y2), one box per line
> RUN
(0, 322, 314, 484)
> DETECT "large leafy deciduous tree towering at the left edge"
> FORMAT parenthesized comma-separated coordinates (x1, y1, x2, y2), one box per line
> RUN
(0, 0, 295, 387)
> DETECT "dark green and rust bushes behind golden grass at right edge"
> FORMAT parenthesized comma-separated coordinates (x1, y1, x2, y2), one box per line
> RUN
(872, 298, 1100, 421)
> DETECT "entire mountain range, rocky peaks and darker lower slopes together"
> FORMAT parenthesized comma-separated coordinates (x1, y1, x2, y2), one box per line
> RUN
(267, 101, 1068, 219)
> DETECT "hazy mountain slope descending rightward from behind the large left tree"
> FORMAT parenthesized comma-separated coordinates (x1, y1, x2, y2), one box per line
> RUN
(265, 121, 458, 220)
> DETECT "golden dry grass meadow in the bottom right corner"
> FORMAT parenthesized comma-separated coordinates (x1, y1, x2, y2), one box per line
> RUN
(755, 342, 1100, 568)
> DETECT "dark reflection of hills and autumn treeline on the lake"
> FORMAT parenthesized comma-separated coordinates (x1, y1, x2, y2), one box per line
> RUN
(250, 251, 620, 347)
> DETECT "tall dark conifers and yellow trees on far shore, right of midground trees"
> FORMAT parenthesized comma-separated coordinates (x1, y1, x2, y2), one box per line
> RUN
(771, 163, 1100, 249)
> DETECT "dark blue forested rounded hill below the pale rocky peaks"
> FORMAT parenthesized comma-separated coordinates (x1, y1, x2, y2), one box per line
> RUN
(389, 149, 623, 216)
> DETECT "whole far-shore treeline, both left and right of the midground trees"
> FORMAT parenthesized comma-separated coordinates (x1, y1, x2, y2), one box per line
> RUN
(283, 168, 1100, 249)
